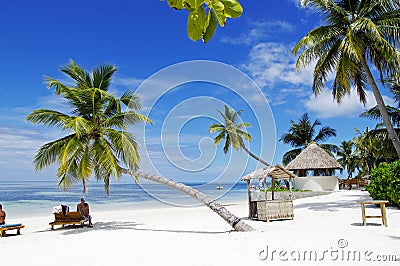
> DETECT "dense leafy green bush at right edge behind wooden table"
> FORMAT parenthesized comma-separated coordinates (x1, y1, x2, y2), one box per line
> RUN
(366, 160, 400, 207)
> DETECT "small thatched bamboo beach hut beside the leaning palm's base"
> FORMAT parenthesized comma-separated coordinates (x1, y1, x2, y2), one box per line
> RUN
(242, 165, 296, 222)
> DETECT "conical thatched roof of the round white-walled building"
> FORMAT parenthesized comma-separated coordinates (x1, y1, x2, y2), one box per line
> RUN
(286, 143, 343, 170)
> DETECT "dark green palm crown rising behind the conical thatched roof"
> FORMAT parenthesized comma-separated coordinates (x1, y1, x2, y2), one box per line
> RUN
(279, 113, 337, 165)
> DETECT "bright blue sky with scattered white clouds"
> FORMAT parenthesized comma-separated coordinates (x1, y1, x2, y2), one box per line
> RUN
(0, 0, 391, 185)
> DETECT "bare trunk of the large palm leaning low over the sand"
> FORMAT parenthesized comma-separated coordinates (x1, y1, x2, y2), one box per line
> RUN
(122, 169, 254, 232)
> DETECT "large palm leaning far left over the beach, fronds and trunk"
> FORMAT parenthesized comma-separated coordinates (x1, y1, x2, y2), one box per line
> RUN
(27, 60, 252, 231)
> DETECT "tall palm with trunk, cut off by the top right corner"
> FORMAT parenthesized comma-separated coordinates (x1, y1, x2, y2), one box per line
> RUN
(292, 0, 400, 156)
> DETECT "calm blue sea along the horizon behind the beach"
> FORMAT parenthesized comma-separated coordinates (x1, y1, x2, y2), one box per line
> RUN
(0, 181, 247, 217)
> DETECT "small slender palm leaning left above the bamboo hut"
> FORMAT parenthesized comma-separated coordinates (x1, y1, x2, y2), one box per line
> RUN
(208, 105, 270, 166)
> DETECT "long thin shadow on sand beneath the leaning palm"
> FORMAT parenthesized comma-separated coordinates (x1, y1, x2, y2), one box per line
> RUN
(57, 221, 232, 235)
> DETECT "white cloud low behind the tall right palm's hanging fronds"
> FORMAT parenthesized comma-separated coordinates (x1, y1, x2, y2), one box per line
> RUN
(305, 89, 394, 118)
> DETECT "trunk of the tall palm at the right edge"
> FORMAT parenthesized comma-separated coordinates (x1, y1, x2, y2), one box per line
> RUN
(361, 57, 400, 157)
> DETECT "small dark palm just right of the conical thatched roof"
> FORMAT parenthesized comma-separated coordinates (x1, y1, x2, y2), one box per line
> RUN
(336, 141, 361, 178)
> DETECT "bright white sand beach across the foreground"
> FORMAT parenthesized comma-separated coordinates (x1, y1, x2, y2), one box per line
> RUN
(0, 190, 400, 266)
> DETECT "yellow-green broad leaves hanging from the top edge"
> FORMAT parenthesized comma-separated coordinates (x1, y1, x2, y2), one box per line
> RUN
(168, 0, 243, 43)
